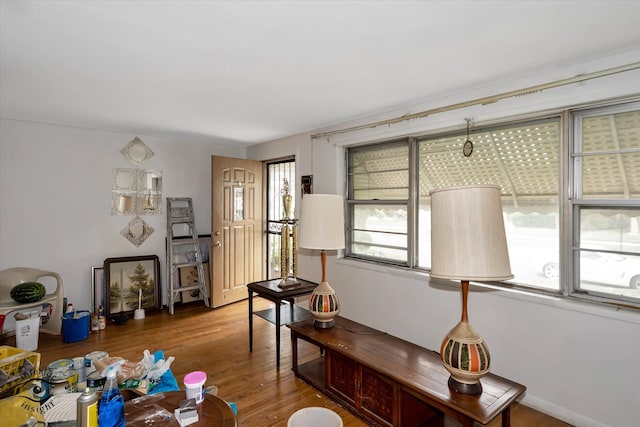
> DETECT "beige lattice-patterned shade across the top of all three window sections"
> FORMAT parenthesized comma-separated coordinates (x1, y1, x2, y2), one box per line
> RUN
(349, 111, 640, 205)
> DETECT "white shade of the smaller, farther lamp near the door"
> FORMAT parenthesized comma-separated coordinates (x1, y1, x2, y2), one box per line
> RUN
(298, 194, 344, 250)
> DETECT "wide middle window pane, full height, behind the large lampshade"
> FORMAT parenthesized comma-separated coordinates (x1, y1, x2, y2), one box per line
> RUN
(418, 118, 560, 290)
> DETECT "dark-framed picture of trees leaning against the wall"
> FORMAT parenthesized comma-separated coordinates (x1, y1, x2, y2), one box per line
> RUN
(104, 255, 160, 316)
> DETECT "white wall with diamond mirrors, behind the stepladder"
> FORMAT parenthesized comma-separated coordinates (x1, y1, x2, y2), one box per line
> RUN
(0, 120, 245, 309)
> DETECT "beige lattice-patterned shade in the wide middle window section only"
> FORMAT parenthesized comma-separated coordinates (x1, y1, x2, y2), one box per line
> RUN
(418, 119, 560, 200)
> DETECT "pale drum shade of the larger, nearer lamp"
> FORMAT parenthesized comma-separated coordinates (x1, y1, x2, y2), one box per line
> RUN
(431, 185, 513, 281)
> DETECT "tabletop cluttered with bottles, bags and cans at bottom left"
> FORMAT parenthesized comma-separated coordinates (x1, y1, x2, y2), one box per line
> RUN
(0, 346, 237, 427)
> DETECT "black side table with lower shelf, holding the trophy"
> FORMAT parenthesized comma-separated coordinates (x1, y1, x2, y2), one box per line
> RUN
(247, 279, 318, 369)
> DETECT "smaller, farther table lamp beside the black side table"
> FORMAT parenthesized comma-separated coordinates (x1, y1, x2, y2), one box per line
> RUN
(298, 194, 344, 329)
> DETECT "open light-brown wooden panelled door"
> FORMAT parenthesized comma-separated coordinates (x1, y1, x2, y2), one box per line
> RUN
(210, 156, 264, 307)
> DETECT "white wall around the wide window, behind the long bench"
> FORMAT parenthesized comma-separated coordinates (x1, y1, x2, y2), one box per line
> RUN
(247, 51, 640, 427)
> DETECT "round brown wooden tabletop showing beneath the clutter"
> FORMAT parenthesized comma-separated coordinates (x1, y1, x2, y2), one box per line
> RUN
(124, 390, 238, 427)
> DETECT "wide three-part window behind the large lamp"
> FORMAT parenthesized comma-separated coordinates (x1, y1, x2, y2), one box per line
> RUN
(346, 103, 640, 304)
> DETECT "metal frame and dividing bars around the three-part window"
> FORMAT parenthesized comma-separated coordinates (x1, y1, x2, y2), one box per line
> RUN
(345, 98, 640, 309)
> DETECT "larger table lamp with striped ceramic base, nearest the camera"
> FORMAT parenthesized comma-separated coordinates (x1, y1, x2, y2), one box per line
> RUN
(431, 185, 513, 394)
